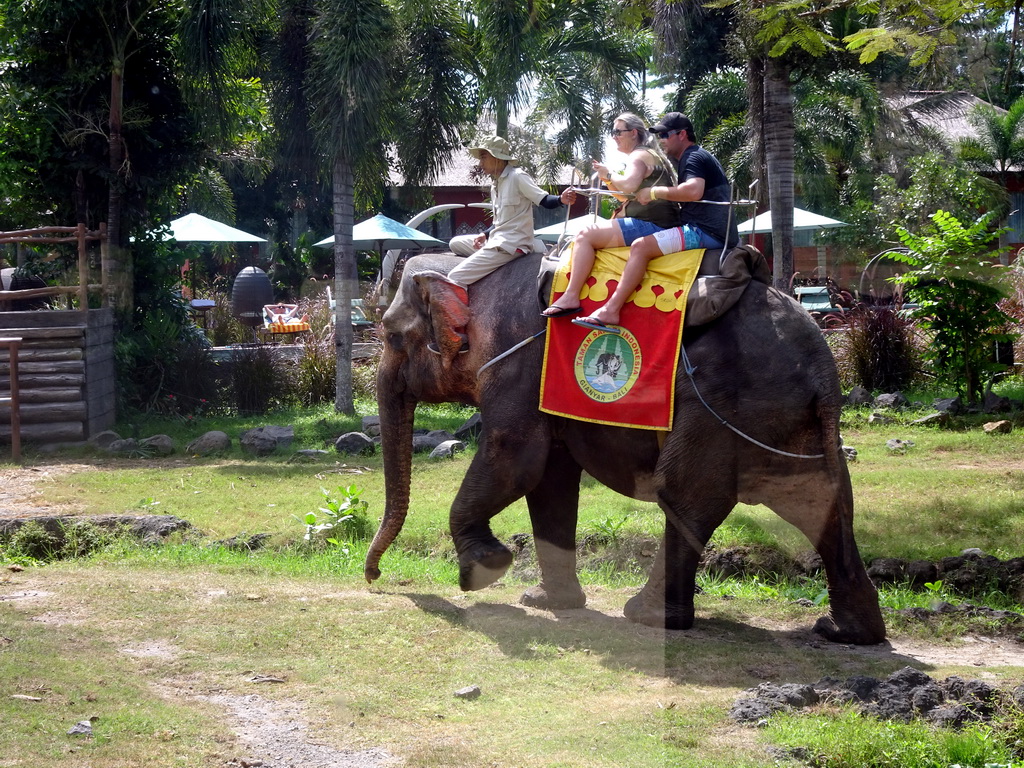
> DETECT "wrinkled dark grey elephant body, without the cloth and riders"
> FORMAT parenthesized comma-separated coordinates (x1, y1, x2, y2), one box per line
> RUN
(365, 255, 885, 644)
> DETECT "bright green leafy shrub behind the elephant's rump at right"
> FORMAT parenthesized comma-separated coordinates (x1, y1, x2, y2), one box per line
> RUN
(893, 210, 1011, 402)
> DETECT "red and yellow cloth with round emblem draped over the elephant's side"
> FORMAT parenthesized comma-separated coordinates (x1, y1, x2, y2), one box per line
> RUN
(541, 248, 703, 430)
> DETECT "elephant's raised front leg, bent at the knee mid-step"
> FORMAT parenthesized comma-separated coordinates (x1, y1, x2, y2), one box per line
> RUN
(450, 422, 550, 591)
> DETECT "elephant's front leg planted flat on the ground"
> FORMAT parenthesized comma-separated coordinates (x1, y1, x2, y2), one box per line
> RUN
(519, 441, 587, 610)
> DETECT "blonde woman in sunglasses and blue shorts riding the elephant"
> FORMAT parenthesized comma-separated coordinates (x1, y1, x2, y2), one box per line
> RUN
(542, 112, 679, 317)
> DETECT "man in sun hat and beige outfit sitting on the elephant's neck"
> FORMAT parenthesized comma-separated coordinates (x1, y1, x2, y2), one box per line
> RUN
(449, 136, 575, 288)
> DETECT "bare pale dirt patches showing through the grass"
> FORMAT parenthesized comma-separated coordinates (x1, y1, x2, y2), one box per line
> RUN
(0, 463, 1024, 768)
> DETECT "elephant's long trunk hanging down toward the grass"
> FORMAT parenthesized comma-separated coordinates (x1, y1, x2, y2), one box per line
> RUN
(362, 360, 416, 582)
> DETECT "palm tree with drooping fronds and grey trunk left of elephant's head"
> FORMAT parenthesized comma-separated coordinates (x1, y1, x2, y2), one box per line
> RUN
(306, 0, 466, 414)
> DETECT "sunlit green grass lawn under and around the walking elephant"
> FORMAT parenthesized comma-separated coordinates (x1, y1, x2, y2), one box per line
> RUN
(0, 399, 1024, 768)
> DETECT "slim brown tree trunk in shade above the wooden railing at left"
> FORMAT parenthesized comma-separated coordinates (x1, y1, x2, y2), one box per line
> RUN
(104, 58, 135, 312)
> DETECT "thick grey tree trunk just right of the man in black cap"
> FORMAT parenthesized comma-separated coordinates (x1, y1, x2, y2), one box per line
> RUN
(764, 56, 795, 293)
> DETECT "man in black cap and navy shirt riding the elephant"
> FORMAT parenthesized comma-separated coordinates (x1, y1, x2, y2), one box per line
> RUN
(573, 112, 739, 327)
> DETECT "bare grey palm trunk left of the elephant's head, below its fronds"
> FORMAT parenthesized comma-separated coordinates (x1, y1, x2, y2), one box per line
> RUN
(332, 157, 358, 416)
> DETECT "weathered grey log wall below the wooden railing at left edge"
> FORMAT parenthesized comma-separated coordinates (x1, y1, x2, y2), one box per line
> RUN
(0, 309, 116, 443)
